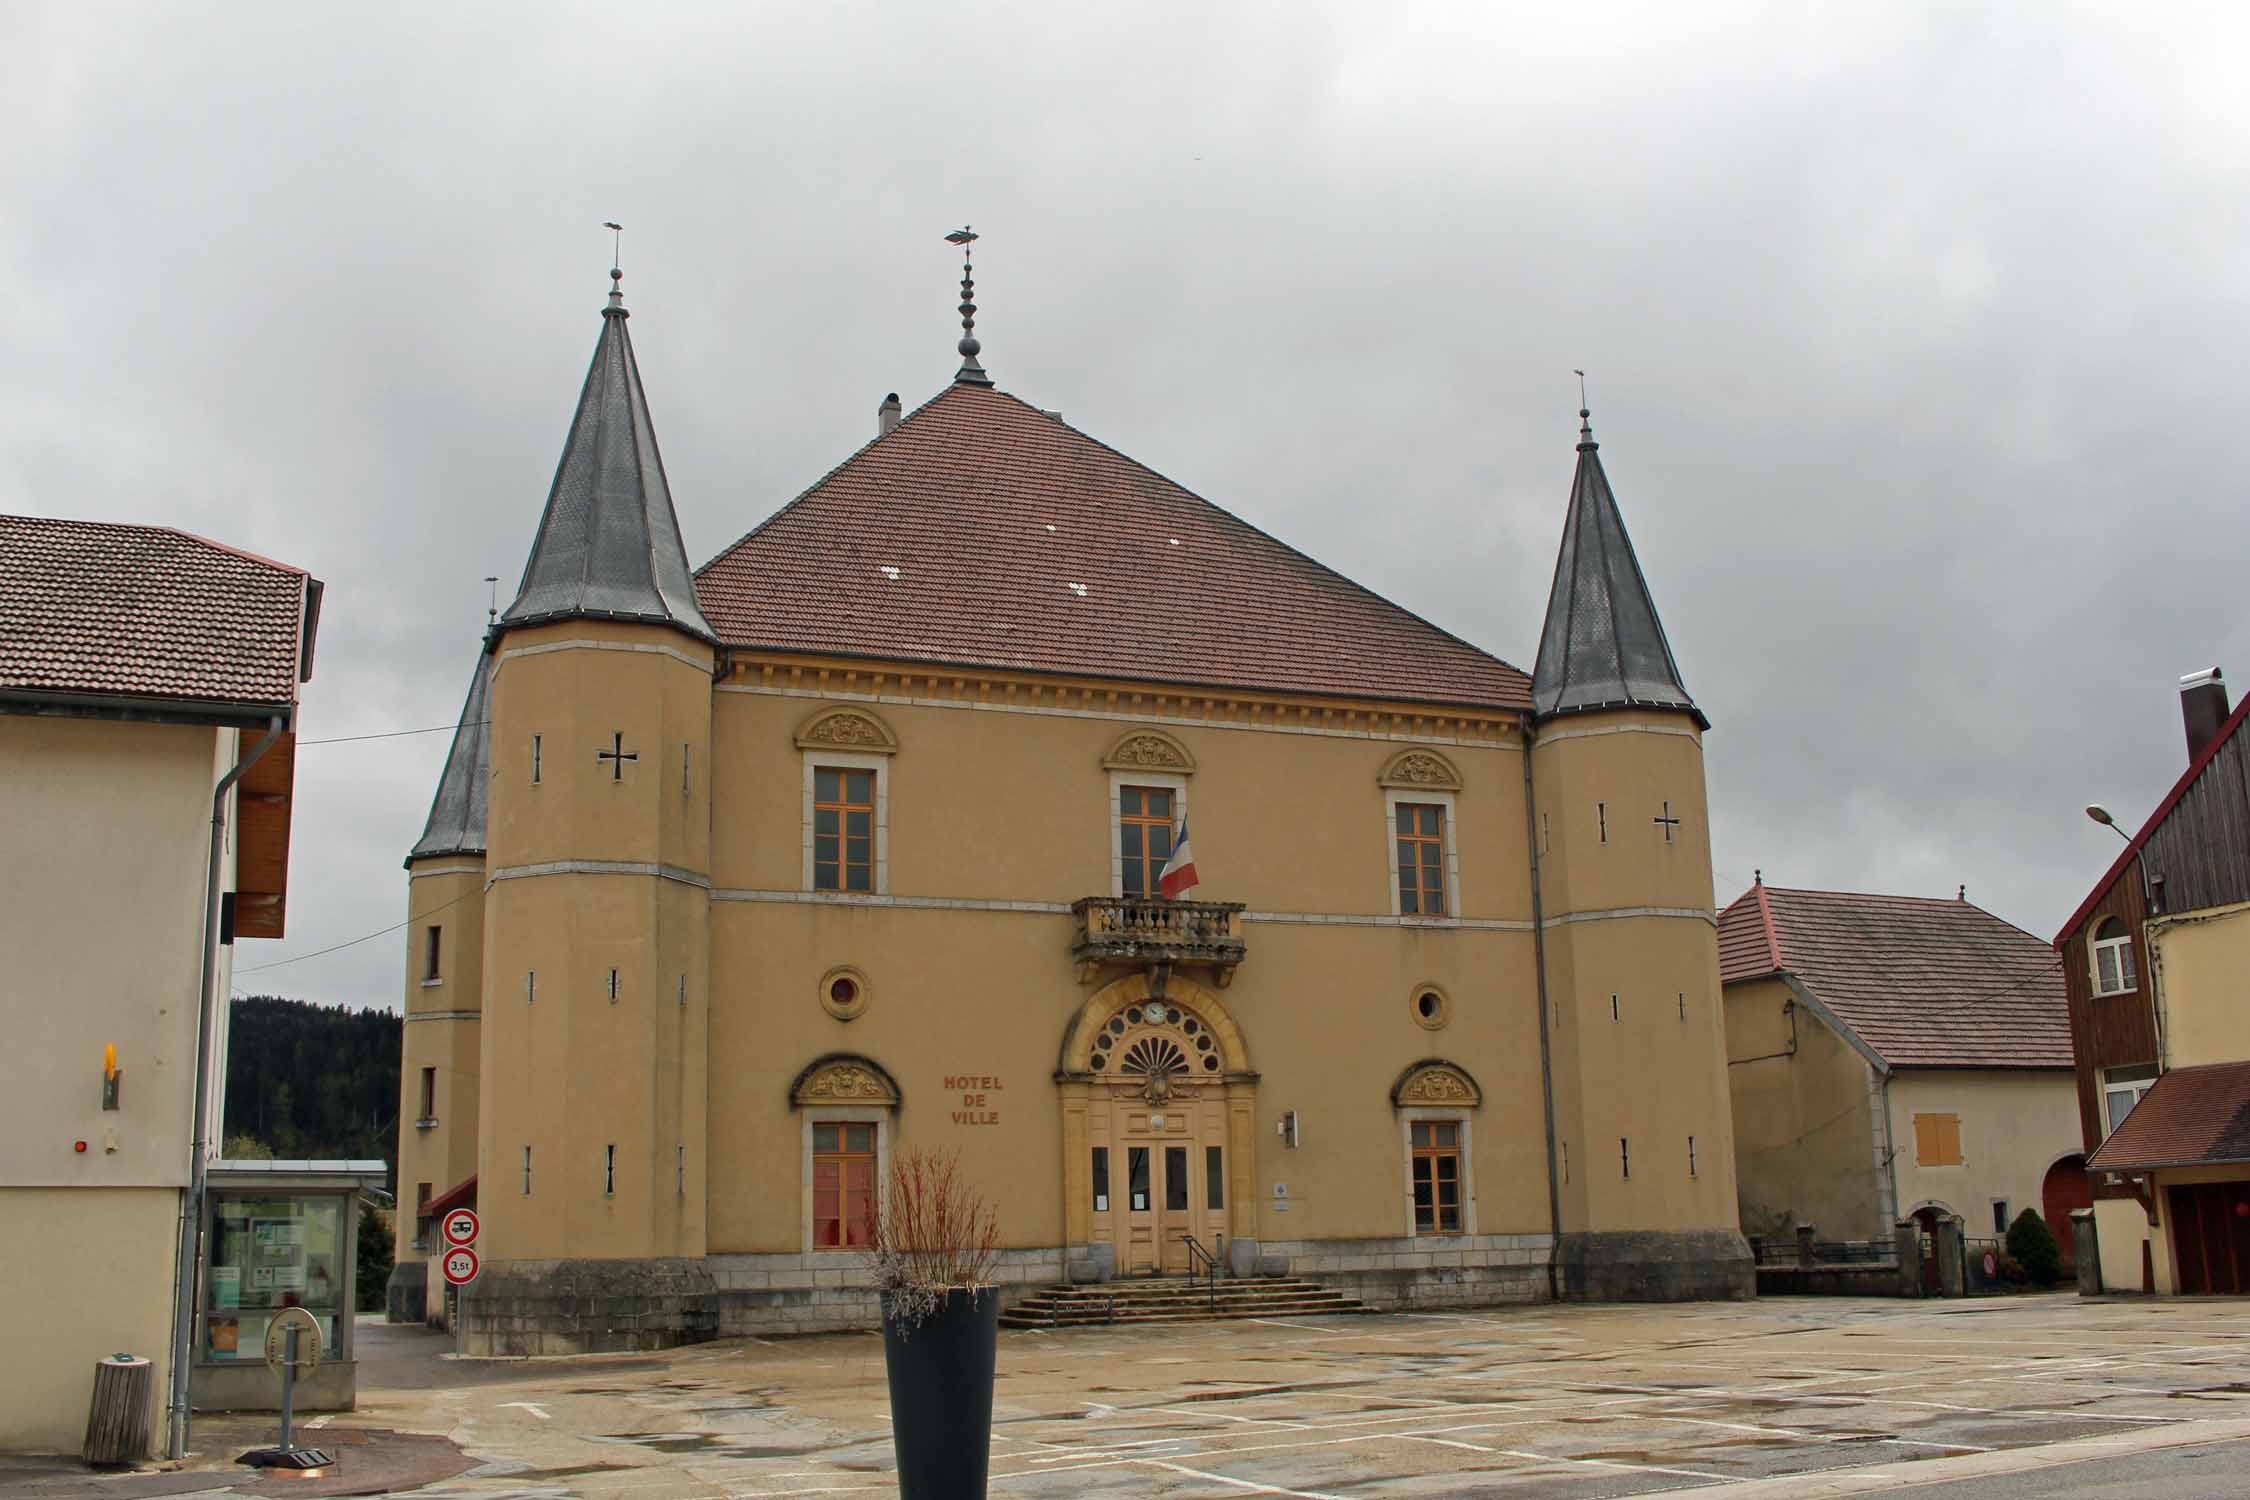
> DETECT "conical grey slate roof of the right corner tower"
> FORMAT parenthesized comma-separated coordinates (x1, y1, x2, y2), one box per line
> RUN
(1532, 409, 1710, 729)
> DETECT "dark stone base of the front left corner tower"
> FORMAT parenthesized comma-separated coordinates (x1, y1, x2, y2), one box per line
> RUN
(459, 1257, 720, 1356)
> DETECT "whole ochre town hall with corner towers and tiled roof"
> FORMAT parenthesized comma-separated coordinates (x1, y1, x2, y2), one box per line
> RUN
(394, 264, 1751, 1352)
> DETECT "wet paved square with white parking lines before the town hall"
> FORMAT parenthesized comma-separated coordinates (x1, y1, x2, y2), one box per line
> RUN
(338, 1295, 2250, 1500)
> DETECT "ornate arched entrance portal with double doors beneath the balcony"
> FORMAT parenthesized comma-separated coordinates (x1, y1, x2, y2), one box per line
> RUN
(1058, 974, 1258, 1275)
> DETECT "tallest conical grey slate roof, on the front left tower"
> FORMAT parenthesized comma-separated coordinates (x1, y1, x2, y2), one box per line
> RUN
(500, 272, 718, 641)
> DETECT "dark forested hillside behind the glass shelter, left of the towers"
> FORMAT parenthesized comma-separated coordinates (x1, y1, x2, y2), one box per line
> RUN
(225, 994, 401, 1167)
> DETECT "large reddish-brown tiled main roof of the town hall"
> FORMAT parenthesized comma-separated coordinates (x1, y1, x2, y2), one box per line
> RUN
(695, 385, 1530, 711)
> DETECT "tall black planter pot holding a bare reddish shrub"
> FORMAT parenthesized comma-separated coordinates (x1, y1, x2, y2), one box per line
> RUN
(882, 1286, 999, 1500)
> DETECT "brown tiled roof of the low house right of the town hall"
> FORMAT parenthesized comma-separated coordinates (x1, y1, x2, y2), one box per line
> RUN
(1719, 884, 2070, 1068)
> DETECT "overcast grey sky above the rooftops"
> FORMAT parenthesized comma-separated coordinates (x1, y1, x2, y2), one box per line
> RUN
(0, 0, 2250, 1005)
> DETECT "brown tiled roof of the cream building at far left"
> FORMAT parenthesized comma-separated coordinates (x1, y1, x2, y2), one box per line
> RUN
(0, 515, 311, 706)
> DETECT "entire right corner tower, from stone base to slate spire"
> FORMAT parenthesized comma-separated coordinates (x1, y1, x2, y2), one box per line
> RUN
(1530, 412, 1753, 1300)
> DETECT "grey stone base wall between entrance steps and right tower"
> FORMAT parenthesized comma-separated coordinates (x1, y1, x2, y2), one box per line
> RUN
(1258, 1235, 1555, 1311)
